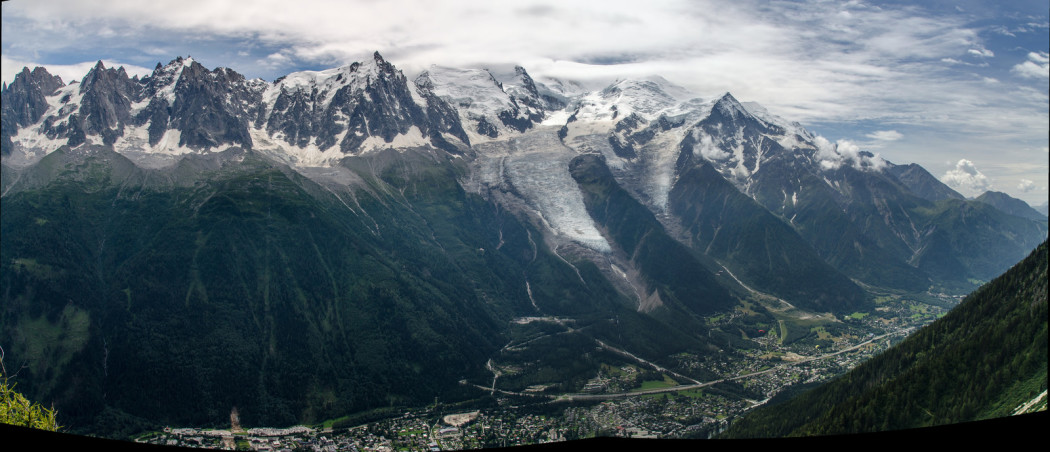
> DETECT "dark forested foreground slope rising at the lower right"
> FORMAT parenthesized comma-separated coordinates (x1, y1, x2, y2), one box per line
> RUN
(725, 238, 1047, 437)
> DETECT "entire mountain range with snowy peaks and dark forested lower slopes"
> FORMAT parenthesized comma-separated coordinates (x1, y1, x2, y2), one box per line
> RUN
(0, 53, 1047, 431)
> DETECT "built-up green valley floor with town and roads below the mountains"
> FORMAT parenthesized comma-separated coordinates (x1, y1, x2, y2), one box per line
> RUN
(135, 294, 960, 451)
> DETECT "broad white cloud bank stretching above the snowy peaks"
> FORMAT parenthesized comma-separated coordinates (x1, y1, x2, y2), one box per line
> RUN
(4, 0, 987, 121)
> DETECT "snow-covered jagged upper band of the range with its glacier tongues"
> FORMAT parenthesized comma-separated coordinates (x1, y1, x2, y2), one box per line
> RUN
(5, 55, 848, 252)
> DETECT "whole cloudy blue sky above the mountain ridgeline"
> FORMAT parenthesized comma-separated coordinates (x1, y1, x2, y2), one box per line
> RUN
(0, 0, 1050, 205)
